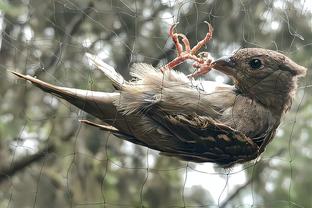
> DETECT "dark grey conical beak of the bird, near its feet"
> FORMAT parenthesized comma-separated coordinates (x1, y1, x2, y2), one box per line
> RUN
(212, 56, 236, 77)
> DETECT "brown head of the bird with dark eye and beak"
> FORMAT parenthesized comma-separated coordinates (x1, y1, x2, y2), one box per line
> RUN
(213, 48, 306, 114)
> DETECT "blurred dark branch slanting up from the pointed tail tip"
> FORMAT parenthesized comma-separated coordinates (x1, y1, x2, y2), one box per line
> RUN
(34, 2, 94, 76)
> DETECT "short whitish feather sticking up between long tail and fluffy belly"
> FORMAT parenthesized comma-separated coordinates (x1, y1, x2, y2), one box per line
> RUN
(86, 53, 126, 89)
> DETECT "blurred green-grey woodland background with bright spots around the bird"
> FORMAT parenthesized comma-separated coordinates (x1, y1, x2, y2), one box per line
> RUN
(0, 0, 312, 208)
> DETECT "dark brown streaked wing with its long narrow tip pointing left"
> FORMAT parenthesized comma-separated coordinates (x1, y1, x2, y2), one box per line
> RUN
(82, 114, 260, 167)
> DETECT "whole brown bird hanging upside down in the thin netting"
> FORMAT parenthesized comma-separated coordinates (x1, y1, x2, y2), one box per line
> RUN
(12, 24, 306, 167)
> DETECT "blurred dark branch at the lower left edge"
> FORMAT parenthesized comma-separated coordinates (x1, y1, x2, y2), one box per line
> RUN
(0, 144, 55, 183)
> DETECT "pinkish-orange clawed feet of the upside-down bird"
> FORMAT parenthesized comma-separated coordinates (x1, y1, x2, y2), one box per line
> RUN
(160, 22, 213, 77)
